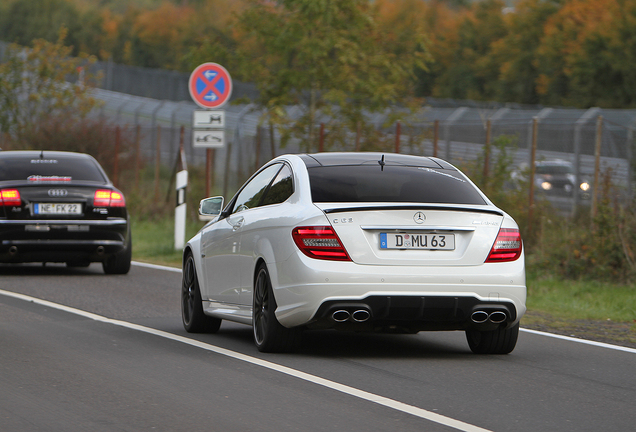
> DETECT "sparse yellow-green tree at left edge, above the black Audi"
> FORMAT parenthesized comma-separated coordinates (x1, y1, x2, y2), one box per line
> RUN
(0, 31, 96, 145)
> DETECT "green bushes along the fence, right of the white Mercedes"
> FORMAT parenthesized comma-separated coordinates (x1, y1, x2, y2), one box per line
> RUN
(462, 135, 636, 284)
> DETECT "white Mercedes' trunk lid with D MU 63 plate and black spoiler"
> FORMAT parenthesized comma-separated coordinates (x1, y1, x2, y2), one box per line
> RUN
(316, 203, 503, 266)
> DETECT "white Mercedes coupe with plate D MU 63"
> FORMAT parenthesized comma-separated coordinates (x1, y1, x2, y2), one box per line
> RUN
(181, 153, 526, 354)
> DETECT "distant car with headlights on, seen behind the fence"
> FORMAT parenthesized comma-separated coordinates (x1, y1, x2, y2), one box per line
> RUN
(513, 159, 591, 200)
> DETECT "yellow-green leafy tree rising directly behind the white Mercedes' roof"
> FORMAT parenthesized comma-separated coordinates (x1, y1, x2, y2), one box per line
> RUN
(226, 0, 426, 149)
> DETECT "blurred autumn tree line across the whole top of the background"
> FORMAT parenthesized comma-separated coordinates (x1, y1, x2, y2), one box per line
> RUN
(0, 0, 636, 109)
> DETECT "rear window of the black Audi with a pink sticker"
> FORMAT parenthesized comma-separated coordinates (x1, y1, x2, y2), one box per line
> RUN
(0, 155, 106, 183)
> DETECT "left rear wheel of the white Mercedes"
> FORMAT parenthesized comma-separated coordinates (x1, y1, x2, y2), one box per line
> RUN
(252, 264, 301, 352)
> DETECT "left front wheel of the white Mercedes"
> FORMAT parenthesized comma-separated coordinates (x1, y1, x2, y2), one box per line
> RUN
(181, 254, 221, 333)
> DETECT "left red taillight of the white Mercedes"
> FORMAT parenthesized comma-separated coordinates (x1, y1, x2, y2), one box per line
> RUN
(292, 226, 351, 261)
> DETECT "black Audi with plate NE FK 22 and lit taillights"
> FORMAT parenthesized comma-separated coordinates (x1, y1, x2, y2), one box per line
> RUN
(0, 150, 132, 274)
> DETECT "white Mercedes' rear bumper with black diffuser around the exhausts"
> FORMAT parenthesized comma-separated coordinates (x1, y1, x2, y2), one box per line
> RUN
(268, 250, 526, 331)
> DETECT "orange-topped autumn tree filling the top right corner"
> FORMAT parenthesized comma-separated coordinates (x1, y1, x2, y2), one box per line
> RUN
(537, 0, 636, 108)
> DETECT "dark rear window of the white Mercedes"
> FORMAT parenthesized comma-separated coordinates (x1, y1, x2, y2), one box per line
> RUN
(307, 165, 486, 205)
